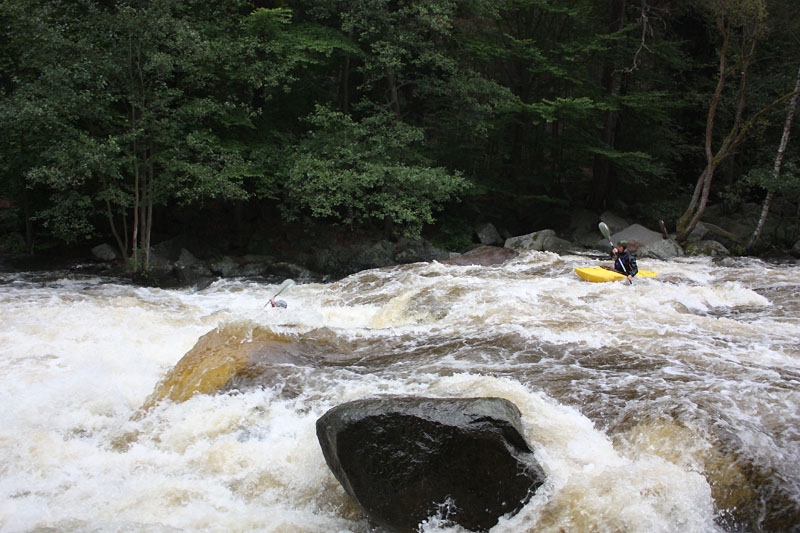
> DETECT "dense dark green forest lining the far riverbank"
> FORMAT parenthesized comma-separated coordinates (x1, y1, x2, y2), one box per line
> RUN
(0, 0, 800, 271)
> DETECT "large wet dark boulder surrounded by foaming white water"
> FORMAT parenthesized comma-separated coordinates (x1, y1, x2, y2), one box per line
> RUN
(317, 397, 543, 531)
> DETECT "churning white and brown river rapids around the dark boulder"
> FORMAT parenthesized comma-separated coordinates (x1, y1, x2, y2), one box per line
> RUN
(0, 252, 800, 533)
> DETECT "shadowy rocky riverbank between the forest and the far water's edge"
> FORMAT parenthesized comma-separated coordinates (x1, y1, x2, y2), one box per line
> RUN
(4, 206, 800, 287)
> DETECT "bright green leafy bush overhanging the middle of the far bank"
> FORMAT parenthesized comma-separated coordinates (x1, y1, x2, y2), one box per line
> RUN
(285, 107, 467, 237)
